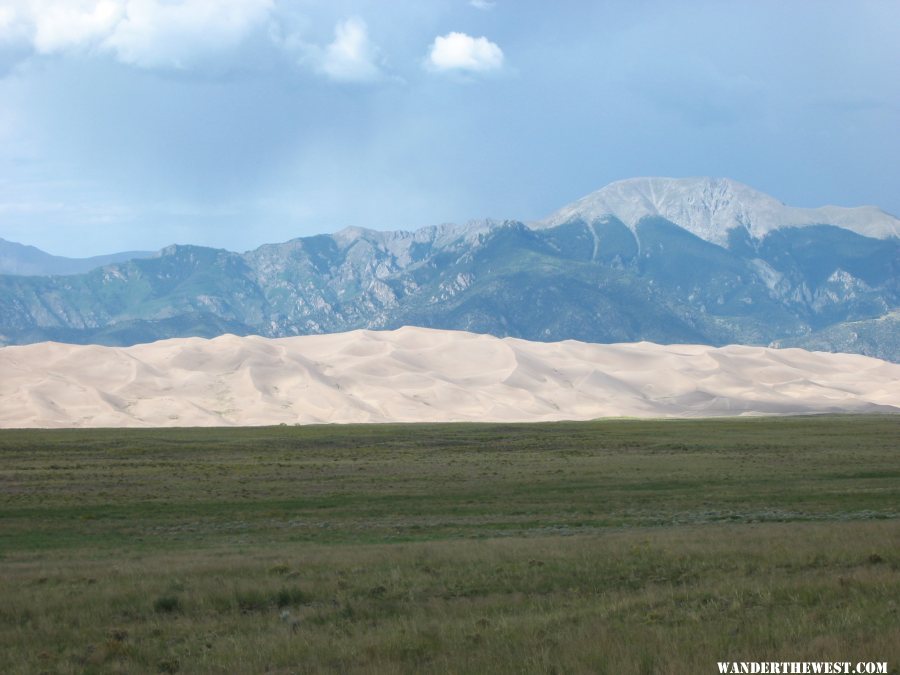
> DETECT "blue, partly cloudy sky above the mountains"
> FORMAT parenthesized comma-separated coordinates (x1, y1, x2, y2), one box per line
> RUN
(0, 0, 900, 257)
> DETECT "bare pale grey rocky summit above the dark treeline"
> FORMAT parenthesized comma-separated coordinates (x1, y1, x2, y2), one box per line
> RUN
(533, 178, 900, 245)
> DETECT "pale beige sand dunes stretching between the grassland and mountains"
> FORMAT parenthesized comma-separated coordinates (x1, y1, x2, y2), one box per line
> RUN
(0, 328, 900, 427)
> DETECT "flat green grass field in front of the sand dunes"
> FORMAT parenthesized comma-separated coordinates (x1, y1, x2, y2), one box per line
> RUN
(0, 416, 900, 674)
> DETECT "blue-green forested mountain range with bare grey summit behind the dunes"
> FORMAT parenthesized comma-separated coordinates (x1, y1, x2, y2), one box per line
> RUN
(0, 178, 900, 361)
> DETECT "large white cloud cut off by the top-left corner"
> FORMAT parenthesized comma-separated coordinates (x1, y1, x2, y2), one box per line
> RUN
(0, 0, 274, 68)
